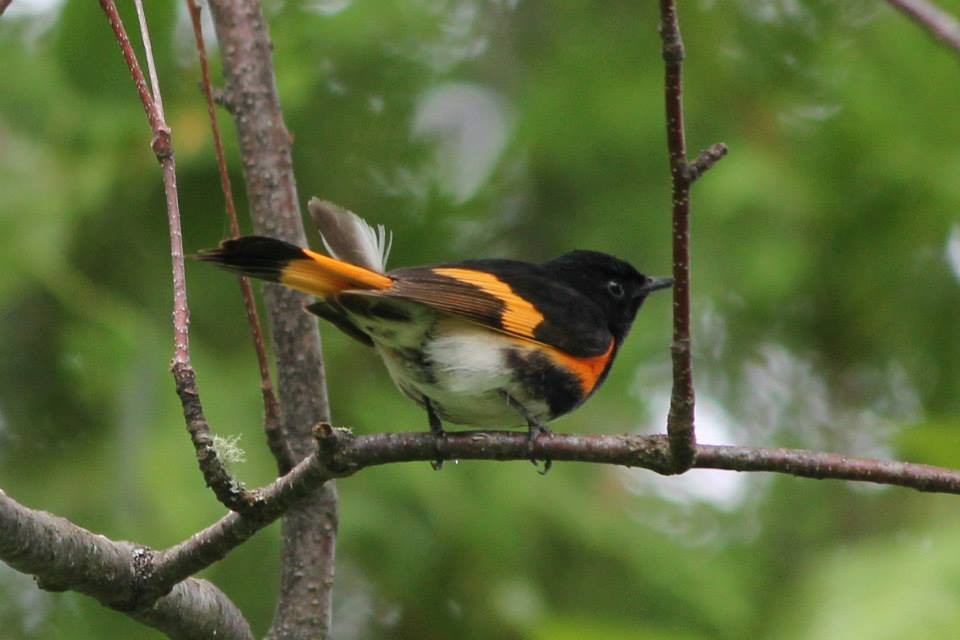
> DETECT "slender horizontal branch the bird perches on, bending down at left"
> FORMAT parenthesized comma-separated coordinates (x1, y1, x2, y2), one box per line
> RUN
(135, 423, 960, 587)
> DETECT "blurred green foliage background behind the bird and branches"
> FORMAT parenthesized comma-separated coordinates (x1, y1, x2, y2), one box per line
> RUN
(0, 0, 960, 640)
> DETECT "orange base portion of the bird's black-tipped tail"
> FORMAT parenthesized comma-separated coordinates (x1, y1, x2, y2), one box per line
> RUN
(280, 249, 393, 298)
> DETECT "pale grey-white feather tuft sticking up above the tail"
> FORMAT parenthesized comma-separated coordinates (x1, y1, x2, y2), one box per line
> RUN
(307, 198, 393, 273)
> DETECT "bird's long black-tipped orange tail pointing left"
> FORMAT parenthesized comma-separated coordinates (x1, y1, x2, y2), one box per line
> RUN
(197, 236, 393, 298)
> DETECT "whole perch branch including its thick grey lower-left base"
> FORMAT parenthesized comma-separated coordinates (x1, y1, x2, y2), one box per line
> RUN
(0, 424, 960, 638)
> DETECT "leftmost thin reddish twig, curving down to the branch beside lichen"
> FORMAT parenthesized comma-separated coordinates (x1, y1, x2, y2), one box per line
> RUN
(100, 0, 251, 509)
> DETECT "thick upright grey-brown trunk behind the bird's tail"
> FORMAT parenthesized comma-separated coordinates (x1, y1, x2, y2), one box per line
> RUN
(210, 0, 337, 638)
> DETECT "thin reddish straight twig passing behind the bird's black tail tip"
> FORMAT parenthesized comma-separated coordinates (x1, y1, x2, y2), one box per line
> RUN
(187, 0, 293, 473)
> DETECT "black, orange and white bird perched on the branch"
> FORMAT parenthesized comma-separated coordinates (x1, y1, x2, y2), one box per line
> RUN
(197, 199, 673, 466)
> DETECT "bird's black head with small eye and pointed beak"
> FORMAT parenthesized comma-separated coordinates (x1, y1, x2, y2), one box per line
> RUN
(543, 250, 673, 343)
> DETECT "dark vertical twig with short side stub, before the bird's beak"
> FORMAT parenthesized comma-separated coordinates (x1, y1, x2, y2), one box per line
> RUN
(660, 0, 726, 472)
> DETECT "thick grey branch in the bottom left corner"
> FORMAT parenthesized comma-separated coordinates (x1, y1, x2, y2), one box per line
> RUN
(0, 491, 253, 640)
